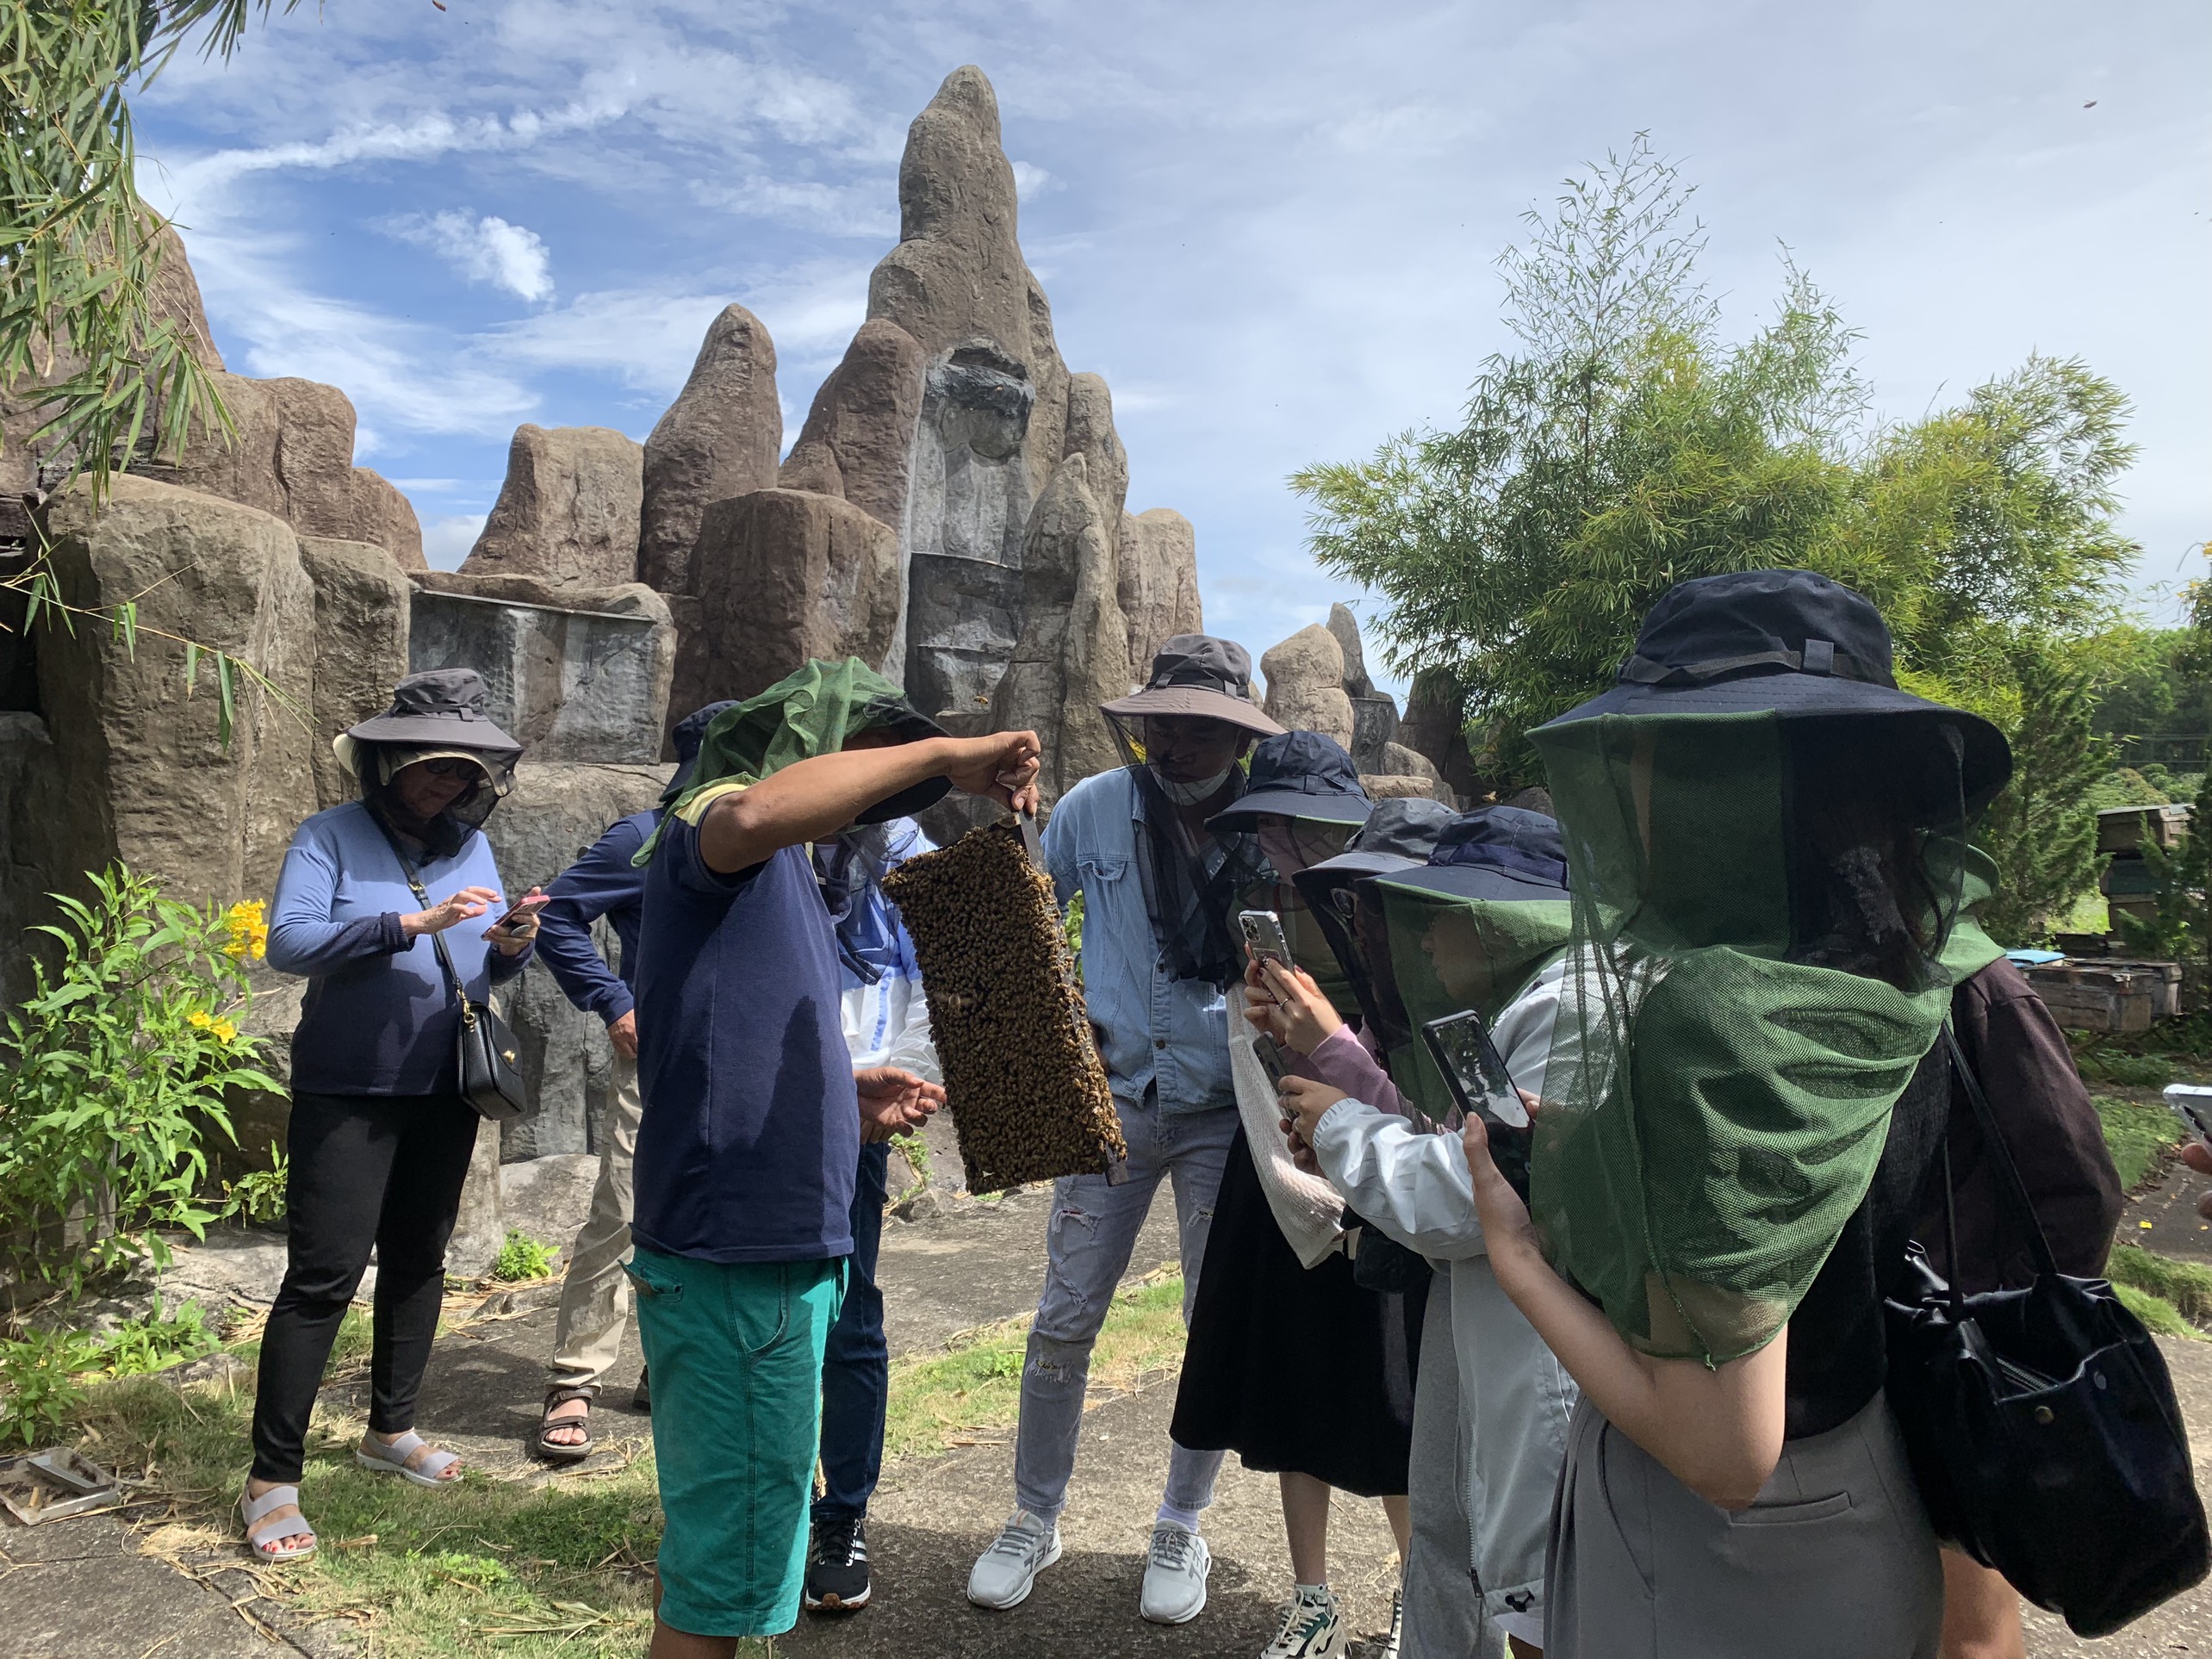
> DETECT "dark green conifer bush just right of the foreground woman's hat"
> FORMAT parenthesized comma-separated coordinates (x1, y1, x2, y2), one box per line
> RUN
(1978, 637, 2110, 945)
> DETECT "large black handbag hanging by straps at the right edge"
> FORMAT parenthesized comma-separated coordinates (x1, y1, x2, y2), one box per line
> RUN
(1885, 1027, 2212, 1637)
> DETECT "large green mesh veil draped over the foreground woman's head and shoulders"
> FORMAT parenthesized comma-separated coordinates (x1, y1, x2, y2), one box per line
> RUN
(1531, 705, 1993, 1364)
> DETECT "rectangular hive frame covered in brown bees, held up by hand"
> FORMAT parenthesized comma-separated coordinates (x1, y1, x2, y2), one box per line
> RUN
(883, 821, 1128, 1192)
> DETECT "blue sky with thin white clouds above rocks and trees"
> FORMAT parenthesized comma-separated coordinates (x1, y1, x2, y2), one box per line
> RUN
(140, 0, 2212, 690)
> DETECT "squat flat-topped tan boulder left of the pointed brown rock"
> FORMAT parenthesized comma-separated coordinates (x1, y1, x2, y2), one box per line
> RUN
(460, 425, 643, 588)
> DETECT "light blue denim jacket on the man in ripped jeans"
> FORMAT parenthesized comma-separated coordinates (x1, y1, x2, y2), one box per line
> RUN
(1044, 767, 1237, 1113)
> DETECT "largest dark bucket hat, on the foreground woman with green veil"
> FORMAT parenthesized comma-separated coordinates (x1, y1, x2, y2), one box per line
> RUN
(1538, 571, 2013, 811)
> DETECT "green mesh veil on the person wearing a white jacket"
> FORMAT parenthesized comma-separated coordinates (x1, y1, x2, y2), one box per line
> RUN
(1354, 865, 1573, 1128)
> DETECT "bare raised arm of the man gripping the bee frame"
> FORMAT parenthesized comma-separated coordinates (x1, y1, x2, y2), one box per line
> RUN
(699, 732, 1037, 876)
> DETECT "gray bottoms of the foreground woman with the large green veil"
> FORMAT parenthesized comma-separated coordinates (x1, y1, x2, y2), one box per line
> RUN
(1544, 1394, 1942, 1659)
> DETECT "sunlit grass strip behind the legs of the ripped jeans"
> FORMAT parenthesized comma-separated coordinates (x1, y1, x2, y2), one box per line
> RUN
(883, 1274, 1184, 1460)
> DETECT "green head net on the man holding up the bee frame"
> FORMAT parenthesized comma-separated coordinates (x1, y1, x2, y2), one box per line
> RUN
(632, 657, 951, 865)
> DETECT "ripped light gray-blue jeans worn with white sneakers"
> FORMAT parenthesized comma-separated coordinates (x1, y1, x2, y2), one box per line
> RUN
(1013, 1090, 1237, 1522)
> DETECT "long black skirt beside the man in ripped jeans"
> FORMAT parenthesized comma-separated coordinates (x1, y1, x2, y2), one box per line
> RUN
(1170, 1128, 1426, 1498)
